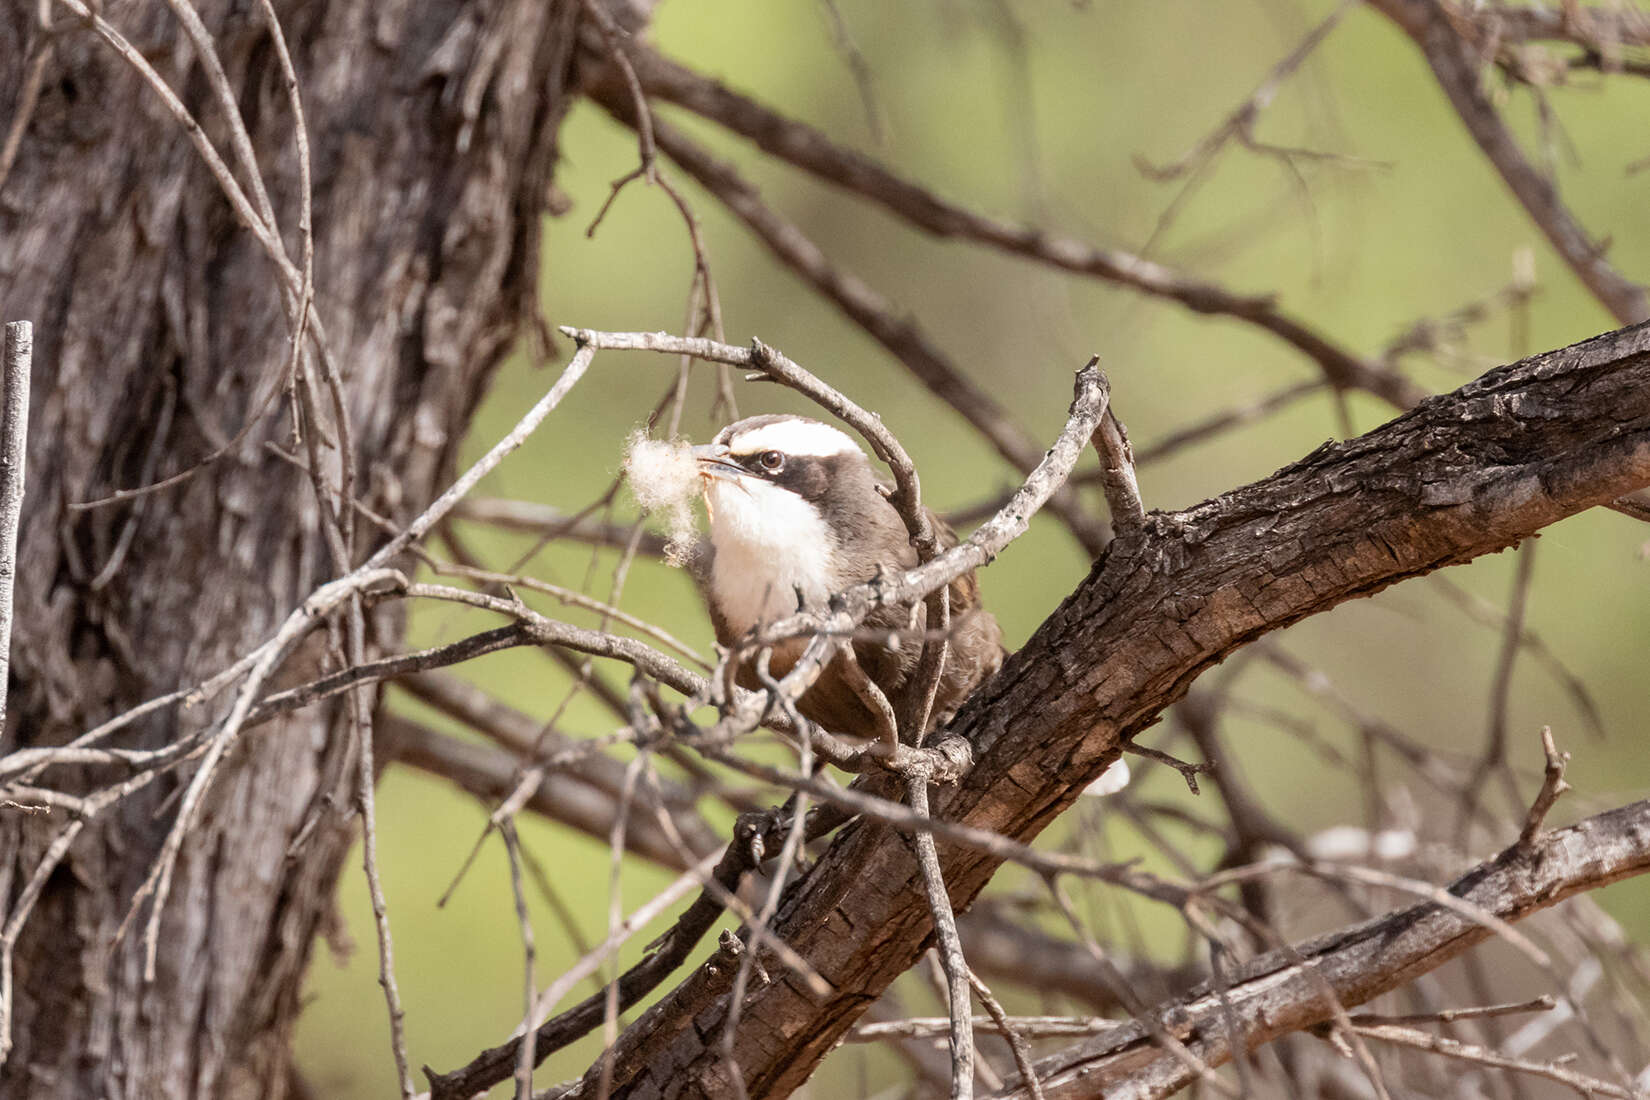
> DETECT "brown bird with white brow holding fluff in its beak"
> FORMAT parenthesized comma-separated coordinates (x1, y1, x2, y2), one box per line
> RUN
(693, 414, 1007, 739)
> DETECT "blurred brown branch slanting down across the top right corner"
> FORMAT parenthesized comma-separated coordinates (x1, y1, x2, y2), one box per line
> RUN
(1371, 0, 1650, 325)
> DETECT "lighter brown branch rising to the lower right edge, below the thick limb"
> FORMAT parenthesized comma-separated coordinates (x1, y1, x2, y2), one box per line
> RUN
(1005, 801, 1650, 1100)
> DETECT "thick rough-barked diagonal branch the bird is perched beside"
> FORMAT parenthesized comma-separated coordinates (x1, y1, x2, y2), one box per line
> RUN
(573, 325, 1650, 1097)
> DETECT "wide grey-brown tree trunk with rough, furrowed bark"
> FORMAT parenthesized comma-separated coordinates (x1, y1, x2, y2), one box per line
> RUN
(0, 0, 578, 1097)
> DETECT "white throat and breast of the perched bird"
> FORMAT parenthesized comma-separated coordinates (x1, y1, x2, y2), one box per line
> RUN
(706, 478, 837, 635)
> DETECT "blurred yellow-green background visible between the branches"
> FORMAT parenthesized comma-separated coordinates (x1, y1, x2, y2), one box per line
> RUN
(299, 0, 1650, 1097)
